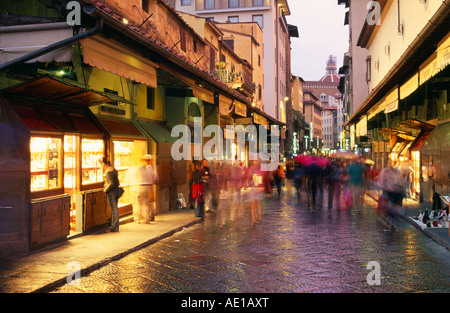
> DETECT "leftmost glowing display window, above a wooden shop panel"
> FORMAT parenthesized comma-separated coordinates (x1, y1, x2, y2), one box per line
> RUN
(30, 137, 63, 192)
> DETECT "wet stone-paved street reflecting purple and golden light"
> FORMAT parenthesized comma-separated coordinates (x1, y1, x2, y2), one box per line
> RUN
(54, 189, 450, 293)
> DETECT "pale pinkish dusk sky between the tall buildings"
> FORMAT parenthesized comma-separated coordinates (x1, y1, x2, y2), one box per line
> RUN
(286, 0, 349, 80)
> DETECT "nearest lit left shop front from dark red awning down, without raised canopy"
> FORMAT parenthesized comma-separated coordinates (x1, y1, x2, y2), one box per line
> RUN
(11, 100, 110, 248)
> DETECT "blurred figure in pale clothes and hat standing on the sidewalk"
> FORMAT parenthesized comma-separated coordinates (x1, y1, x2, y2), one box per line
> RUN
(125, 154, 158, 224)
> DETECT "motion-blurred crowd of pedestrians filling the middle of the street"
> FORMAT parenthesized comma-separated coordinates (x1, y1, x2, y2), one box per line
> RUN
(186, 155, 412, 223)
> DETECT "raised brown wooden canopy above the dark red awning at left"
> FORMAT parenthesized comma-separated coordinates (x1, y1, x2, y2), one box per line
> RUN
(2, 77, 125, 107)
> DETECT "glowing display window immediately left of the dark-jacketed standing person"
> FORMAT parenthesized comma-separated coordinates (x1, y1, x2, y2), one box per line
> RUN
(81, 138, 105, 185)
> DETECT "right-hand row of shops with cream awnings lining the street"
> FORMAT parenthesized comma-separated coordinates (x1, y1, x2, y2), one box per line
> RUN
(347, 32, 450, 205)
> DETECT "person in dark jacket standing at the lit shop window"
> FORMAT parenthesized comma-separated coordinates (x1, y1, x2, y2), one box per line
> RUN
(99, 158, 121, 232)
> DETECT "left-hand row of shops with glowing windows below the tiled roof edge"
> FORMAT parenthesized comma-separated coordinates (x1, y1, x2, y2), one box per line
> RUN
(0, 1, 283, 257)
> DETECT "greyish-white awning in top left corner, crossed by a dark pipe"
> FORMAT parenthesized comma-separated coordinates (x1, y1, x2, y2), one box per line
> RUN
(0, 22, 73, 64)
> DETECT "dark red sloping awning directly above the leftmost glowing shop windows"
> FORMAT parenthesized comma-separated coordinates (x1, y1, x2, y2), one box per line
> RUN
(8, 98, 105, 135)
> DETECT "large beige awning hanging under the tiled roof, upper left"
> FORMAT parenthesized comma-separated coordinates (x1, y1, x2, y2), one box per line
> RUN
(81, 36, 158, 88)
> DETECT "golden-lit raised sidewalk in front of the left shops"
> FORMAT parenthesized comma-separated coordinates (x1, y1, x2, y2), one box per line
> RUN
(0, 209, 202, 293)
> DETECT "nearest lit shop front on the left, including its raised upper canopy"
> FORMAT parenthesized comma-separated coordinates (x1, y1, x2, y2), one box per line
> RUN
(2, 77, 129, 249)
